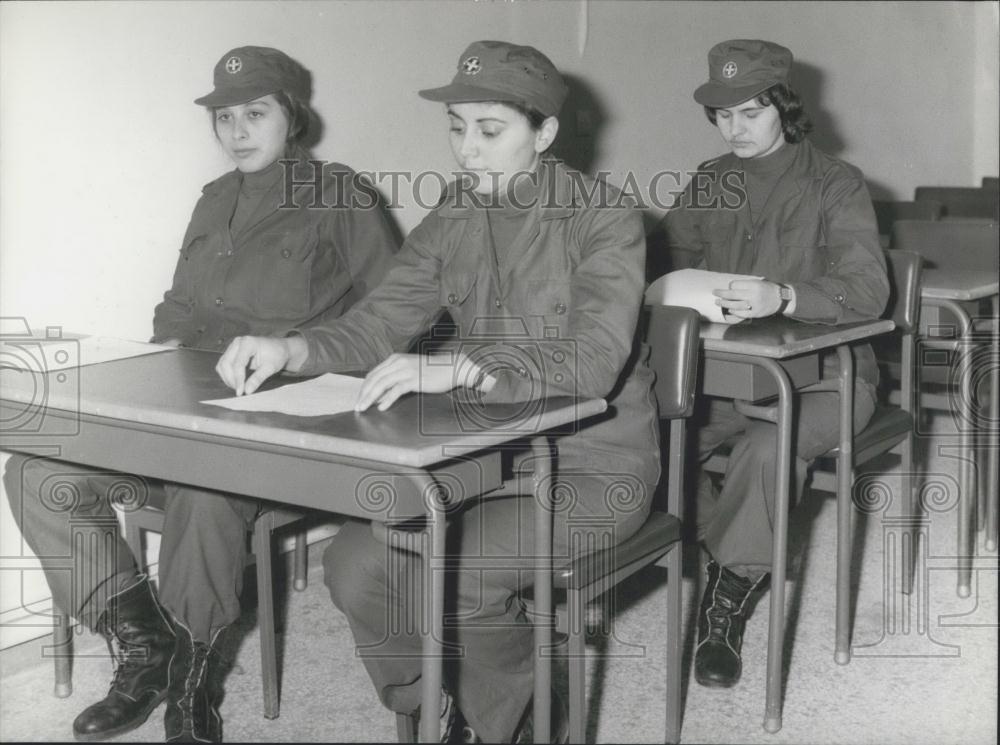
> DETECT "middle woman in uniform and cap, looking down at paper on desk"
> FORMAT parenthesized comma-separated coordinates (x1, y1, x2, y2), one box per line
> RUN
(217, 41, 659, 742)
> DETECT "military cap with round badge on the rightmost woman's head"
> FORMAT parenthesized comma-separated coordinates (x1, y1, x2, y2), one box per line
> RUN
(694, 39, 792, 109)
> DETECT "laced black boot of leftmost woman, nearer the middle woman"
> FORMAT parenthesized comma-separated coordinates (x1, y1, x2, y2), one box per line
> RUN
(163, 622, 223, 742)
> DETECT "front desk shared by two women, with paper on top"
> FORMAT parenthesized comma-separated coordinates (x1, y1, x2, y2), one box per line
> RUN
(0, 342, 607, 742)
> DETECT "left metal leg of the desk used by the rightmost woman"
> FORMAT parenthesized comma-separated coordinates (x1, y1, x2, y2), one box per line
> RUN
(755, 359, 792, 733)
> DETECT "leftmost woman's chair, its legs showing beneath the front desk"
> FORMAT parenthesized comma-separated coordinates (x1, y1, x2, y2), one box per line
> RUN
(53, 489, 307, 719)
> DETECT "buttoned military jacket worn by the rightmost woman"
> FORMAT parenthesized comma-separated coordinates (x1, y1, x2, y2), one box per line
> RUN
(665, 140, 889, 381)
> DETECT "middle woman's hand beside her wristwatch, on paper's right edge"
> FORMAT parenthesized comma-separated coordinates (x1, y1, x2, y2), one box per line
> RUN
(354, 354, 472, 411)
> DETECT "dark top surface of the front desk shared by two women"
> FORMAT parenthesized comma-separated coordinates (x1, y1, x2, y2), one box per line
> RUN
(0, 349, 607, 467)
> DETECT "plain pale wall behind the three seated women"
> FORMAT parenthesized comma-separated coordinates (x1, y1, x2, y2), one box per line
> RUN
(0, 0, 1000, 632)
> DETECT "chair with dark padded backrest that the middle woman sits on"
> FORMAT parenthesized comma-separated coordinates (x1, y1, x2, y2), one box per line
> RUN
(553, 306, 699, 742)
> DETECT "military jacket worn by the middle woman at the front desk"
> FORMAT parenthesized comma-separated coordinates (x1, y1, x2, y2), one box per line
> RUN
(300, 159, 659, 483)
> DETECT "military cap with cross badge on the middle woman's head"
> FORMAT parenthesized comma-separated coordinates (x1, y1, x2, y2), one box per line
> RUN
(420, 41, 568, 116)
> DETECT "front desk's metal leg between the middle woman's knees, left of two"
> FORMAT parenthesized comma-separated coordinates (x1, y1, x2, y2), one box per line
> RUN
(420, 480, 447, 742)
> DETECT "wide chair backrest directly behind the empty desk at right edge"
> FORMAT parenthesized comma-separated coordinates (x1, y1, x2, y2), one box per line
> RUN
(890, 220, 1000, 275)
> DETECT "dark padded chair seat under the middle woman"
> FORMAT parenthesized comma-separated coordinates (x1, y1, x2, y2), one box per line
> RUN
(552, 512, 681, 590)
